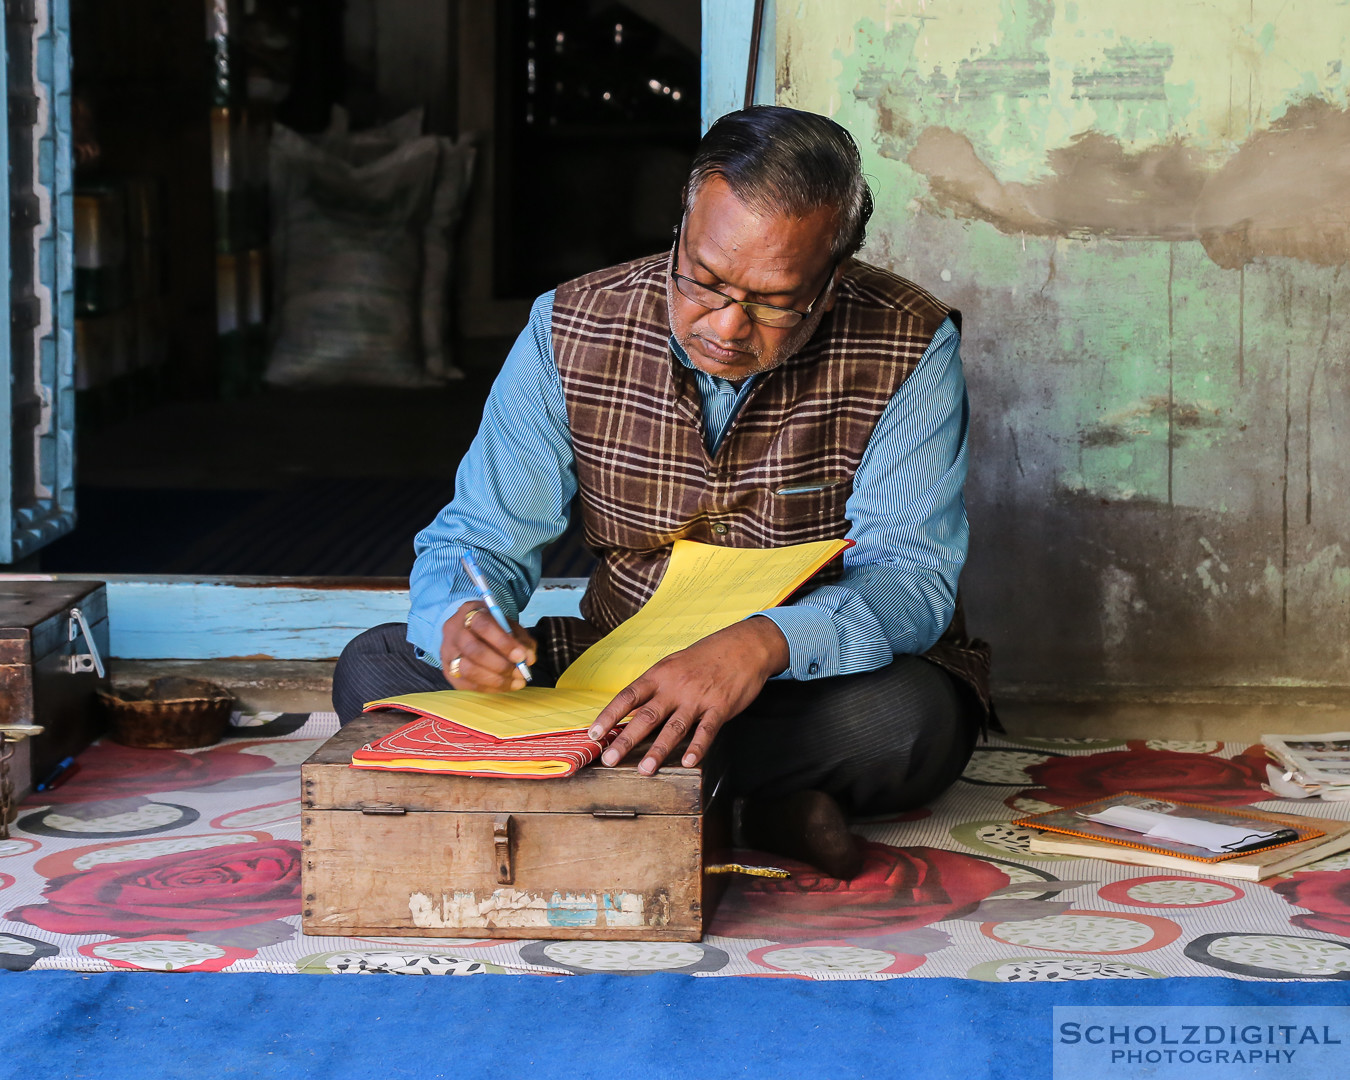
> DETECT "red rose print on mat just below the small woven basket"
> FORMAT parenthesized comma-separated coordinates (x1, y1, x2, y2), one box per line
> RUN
(27, 743, 273, 805)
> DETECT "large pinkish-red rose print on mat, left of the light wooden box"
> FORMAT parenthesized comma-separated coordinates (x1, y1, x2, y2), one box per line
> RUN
(7, 840, 300, 937)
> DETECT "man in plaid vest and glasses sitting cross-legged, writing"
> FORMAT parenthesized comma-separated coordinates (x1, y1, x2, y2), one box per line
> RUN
(333, 107, 988, 878)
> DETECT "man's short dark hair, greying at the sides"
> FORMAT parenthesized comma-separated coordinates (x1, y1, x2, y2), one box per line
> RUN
(684, 105, 872, 263)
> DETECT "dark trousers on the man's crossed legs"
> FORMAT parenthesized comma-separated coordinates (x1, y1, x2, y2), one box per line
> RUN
(333, 622, 979, 815)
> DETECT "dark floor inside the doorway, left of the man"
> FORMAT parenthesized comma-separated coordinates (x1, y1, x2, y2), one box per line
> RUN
(43, 353, 509, 576)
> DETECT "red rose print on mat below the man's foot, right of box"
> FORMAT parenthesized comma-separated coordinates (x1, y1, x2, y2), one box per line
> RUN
(710, 842, 1008, 941)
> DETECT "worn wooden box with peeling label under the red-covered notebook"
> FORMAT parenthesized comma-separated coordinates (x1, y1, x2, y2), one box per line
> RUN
(300, 713, 730, 941)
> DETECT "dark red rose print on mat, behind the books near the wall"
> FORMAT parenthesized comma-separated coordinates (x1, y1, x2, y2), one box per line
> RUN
(1014, 747, 1270, 806)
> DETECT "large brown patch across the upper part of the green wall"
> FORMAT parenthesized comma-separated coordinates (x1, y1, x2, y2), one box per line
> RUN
(901, 99, 1350, 269)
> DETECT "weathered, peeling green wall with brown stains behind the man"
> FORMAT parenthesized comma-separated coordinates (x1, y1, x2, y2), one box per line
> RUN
(778, 0, 1350, 686)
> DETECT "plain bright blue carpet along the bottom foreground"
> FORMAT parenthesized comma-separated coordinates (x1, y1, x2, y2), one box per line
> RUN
(0, 972, 1350, 1080)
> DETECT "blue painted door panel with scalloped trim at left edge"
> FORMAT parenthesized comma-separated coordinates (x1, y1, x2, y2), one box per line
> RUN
(0, 0, 76, 563)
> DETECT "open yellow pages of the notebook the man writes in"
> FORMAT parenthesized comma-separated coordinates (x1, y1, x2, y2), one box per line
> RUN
(366, 540, 852, 740)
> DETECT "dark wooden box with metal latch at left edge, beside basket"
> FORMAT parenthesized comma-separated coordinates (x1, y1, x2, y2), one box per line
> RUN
(0, 581, 108, 799)
